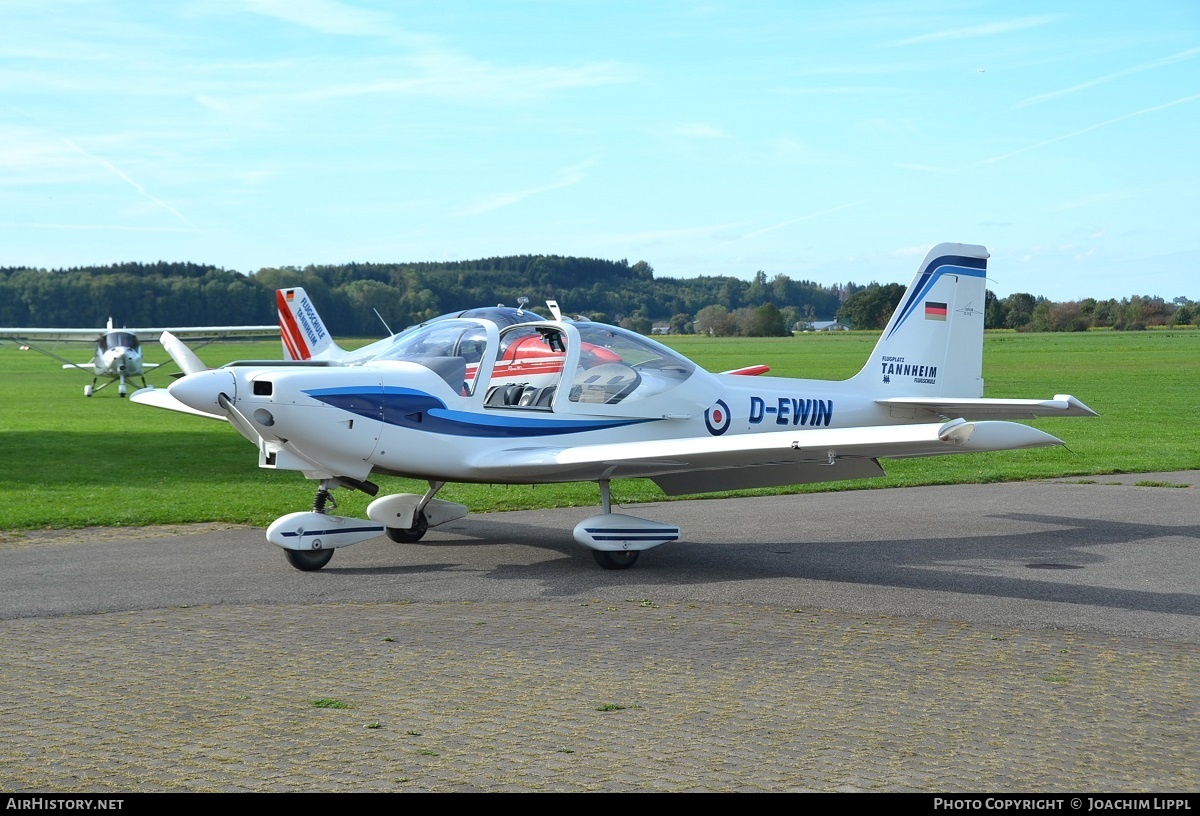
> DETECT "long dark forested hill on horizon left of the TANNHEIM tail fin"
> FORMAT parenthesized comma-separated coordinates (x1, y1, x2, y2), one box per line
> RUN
(0, 256, 842, 336)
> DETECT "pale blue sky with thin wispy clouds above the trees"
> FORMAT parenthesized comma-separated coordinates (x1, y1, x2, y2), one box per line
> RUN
(0, 0, 1200, 302)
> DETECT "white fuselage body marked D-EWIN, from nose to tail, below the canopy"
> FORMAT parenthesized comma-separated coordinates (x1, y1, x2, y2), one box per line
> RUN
(172, 352, 892, 484)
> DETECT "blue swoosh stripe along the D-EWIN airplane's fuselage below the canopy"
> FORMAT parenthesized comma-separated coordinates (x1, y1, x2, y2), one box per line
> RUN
(305, 385, 650, 437)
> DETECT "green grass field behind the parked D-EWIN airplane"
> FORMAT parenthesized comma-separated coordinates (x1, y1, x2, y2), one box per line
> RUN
(0, 330, 1200, 530)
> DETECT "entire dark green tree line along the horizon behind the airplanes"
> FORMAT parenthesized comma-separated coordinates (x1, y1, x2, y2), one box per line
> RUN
(0, 256, 1198, 337)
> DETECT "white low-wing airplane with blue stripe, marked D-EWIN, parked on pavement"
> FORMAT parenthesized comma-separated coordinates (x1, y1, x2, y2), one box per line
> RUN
(131, 244, 1094, 570)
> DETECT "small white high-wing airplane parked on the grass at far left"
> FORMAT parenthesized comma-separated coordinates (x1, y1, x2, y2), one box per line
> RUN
(0, 318, 280, 397)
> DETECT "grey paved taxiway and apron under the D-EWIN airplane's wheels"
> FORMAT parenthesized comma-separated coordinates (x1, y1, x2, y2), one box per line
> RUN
(0, 472, 1200, 793)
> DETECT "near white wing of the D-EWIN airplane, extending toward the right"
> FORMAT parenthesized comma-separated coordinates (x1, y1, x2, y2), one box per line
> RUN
(472, 419, 1062, 496)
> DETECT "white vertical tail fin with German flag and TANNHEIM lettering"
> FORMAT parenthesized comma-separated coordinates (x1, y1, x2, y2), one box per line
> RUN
(853, 244, 988, 398)
